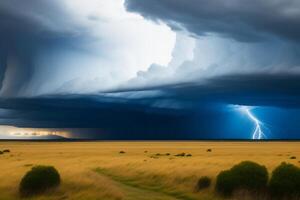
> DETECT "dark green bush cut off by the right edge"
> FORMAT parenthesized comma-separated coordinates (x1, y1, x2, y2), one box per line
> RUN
(269, 162, 300, 199)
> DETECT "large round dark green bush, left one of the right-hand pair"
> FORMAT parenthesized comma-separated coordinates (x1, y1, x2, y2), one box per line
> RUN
(216, 161, 268, 196)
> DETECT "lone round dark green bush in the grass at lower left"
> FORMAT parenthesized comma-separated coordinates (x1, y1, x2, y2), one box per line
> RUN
(19, 166, 60, 196)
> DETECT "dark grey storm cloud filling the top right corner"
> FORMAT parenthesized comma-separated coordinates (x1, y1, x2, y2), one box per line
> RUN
(125, 0, 300, 42)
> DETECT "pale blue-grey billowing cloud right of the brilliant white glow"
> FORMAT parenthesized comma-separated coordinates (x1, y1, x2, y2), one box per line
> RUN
(119, 32, 300, 90)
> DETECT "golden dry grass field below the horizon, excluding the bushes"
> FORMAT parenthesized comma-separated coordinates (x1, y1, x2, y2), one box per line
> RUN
(0, 141, 300, 200)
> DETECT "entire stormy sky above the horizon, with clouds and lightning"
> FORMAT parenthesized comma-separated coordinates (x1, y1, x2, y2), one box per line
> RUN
(0, 0, 300, 139)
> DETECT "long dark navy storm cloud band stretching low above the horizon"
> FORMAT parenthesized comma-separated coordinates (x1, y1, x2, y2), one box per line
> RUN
(0, 74, 300, 139)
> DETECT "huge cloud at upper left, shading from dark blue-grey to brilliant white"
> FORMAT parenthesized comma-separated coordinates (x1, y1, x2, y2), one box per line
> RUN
(0, 0, 175, 97)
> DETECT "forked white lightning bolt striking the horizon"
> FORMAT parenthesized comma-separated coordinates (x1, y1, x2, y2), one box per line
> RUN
(239, 106, 266, 140)
